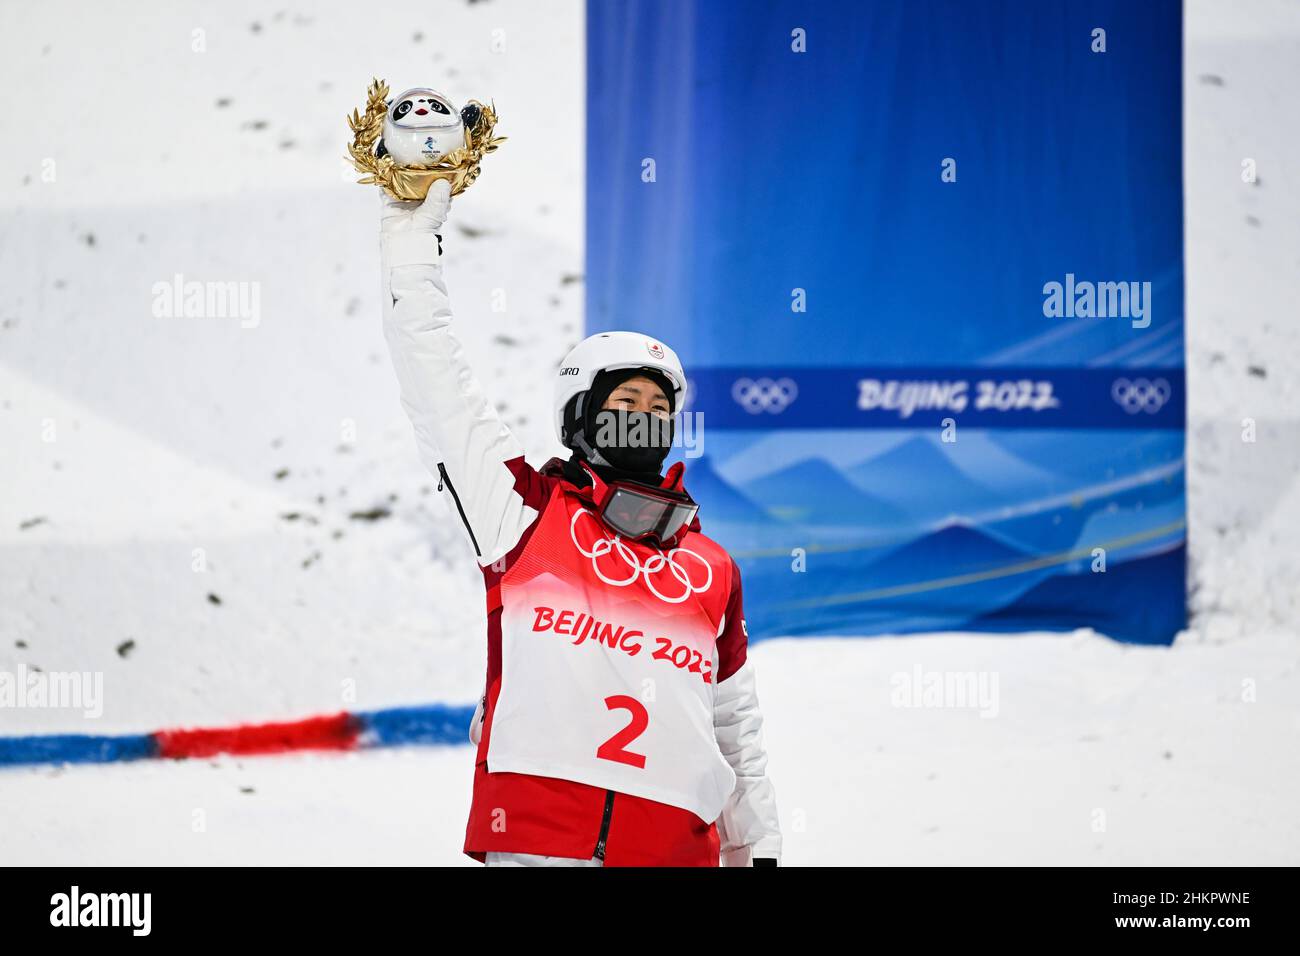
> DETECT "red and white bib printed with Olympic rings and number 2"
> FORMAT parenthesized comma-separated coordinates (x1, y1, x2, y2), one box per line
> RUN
(488, 488, 736, 822)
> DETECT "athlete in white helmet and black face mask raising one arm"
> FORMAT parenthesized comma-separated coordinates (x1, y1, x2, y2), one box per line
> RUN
(381, 182, 781, 866)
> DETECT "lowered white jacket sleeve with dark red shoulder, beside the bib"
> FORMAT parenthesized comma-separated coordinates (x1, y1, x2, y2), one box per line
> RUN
(714, 562, 781, 866)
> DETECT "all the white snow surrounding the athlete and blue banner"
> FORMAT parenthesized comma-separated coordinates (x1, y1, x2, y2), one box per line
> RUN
(0, 0, 1300, 865)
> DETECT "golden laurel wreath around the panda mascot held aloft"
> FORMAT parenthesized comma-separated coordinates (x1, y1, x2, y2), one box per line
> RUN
(347, 79, 506, 200)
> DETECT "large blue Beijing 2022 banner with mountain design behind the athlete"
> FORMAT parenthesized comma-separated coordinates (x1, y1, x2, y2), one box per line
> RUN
(586, 0, 1187, 643)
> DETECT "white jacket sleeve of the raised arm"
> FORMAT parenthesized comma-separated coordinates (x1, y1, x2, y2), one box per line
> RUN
(380, 213, 551, 566)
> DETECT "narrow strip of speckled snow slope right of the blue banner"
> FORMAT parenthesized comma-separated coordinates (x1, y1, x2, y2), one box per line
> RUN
(1183, 0, 1300, 640)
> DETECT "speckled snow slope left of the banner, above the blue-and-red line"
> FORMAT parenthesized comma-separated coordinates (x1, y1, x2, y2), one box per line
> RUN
(0, 3, 582, 732)
